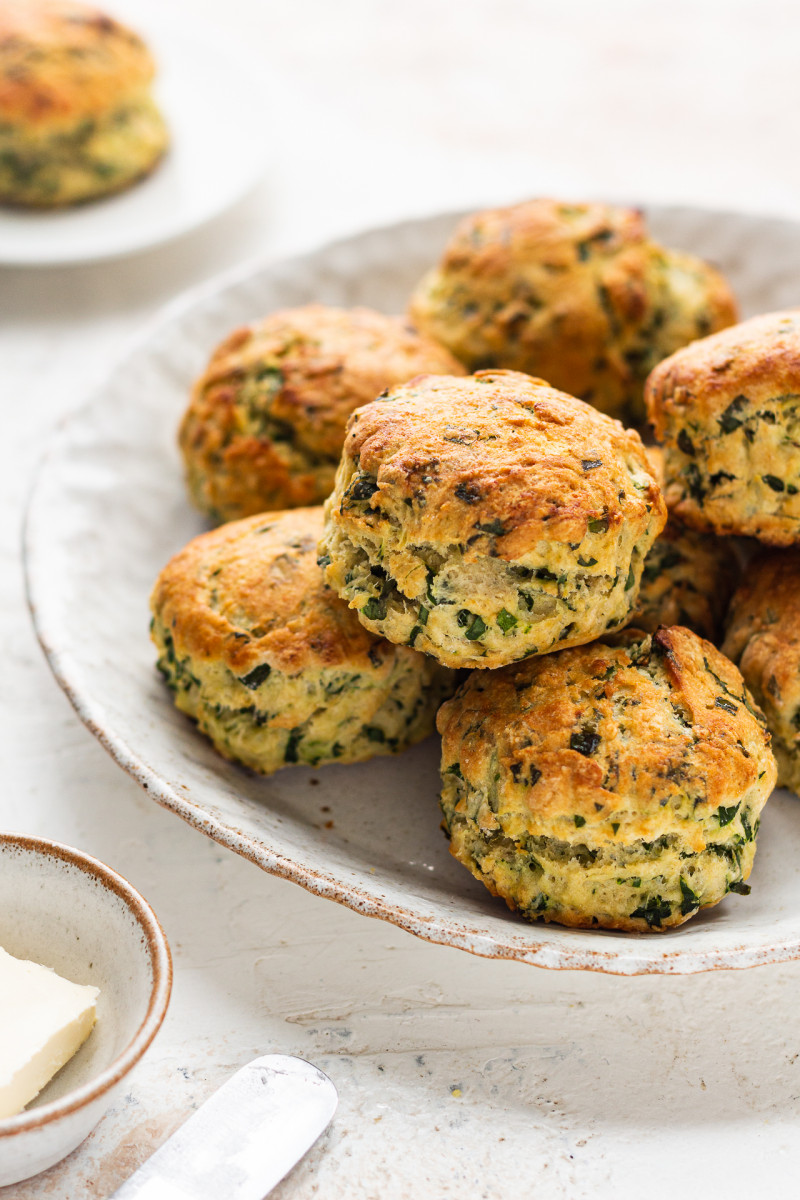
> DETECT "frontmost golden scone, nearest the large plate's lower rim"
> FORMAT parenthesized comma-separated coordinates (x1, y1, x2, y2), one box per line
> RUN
(437, 626, 776, 931)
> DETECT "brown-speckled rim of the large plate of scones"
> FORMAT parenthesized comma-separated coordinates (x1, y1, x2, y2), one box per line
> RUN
(23, 206, 800, 976)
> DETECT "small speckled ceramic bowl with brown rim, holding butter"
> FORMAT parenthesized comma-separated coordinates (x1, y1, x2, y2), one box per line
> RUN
(0, 834, 172, 1186)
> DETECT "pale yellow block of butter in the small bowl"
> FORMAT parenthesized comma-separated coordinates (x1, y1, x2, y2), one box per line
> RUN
(0, 948, 100, 1117)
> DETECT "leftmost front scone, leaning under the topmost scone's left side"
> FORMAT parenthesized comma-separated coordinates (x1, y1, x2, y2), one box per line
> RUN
(151, 509, 453, 774)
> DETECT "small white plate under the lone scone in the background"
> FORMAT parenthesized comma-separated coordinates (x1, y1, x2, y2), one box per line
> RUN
(0, 0, 273, 266)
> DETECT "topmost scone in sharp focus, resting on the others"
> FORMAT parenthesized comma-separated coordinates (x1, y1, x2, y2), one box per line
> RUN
(320, 371, 666, 667)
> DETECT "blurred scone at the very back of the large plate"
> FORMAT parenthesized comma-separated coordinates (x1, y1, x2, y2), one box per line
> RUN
(410, 199, 736, 421)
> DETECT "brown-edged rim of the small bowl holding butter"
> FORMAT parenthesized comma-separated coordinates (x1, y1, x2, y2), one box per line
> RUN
(0, 833, 173, 1141)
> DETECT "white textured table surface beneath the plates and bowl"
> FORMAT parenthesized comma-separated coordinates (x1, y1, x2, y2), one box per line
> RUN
(0, 0, 800, 1200)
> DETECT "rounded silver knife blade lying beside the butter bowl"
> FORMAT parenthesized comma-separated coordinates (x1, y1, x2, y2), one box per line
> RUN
(110, 1055, 338, 1200)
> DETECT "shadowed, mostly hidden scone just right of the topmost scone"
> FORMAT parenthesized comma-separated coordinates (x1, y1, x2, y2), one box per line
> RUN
(631, 521, 739, 646)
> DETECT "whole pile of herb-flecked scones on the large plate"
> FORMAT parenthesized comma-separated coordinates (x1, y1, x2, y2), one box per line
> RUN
(152, 200, 800, 932)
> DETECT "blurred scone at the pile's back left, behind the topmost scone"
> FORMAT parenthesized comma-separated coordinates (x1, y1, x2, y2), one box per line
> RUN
(180, 304, 463, 521)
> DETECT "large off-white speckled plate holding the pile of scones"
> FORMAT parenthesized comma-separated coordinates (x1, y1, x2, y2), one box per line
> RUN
(26, 209, 800, 974)
